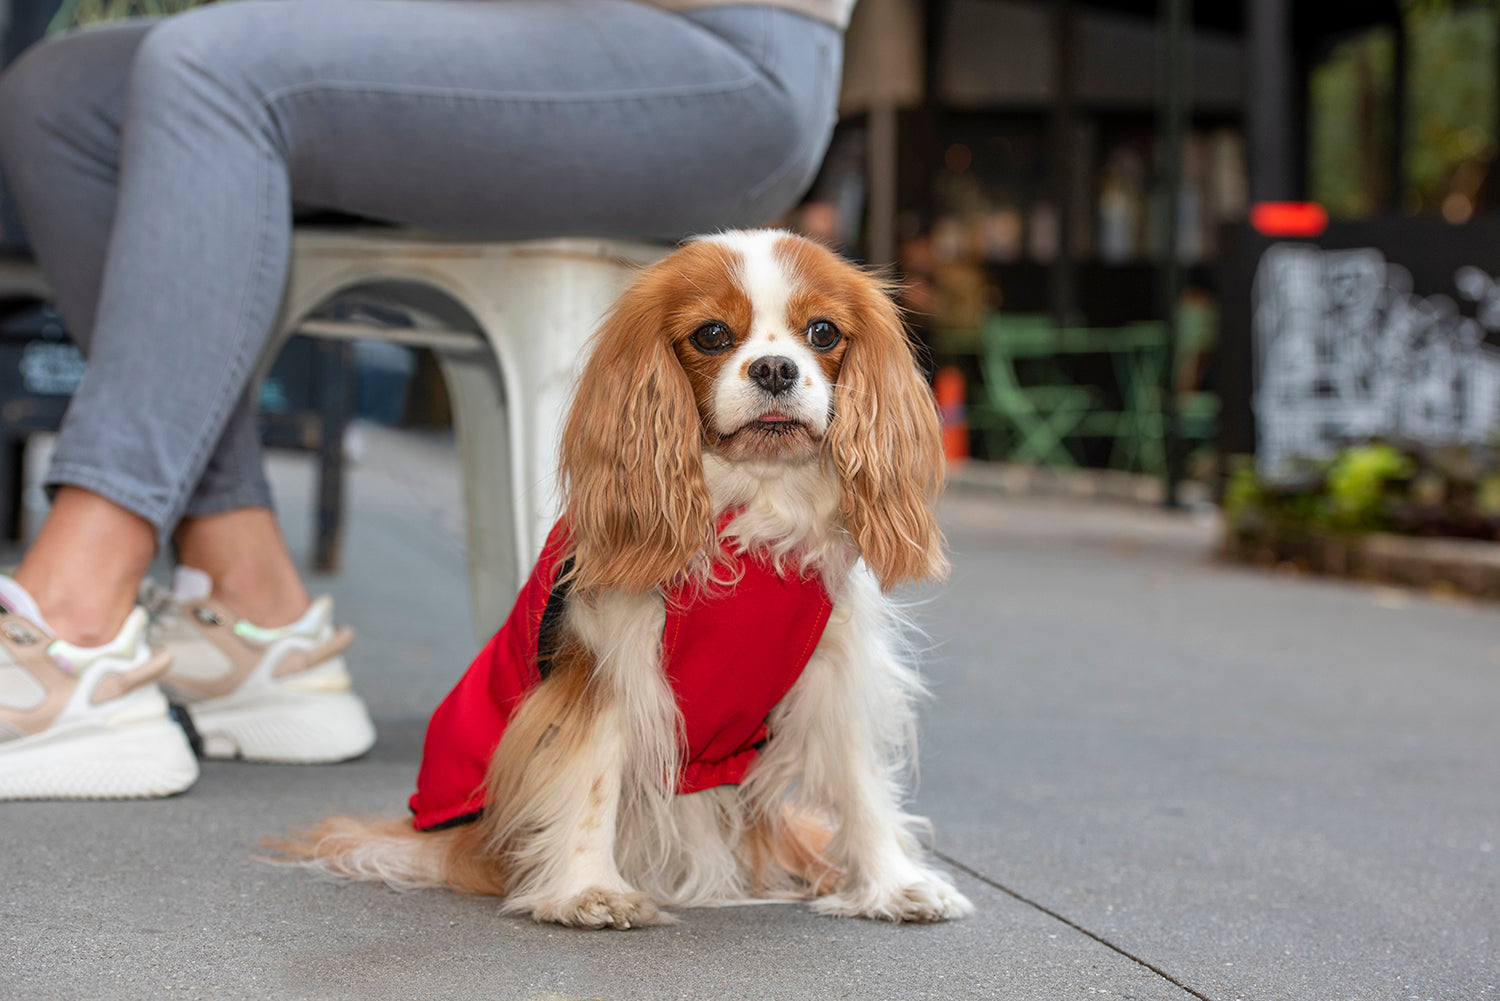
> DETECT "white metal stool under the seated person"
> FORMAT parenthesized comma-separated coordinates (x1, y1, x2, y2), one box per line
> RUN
(271, 228, 666, 639)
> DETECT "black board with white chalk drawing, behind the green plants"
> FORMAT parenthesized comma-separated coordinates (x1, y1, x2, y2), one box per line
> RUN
(1223, 219, 1500, 477)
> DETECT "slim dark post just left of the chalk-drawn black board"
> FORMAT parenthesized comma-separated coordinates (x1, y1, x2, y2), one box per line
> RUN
(1161, 0, 1190, 507)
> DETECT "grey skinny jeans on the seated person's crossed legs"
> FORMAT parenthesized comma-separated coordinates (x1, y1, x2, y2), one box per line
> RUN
(0, 0, 842, 534)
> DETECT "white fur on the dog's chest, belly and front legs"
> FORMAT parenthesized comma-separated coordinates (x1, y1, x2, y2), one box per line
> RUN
(543, 458, 972, 921)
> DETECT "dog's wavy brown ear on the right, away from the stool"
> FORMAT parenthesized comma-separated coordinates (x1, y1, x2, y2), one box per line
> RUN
(825, 281, 948, 590)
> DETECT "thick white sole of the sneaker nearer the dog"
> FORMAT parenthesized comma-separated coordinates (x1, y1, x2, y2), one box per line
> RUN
(186, 690, 375, 764)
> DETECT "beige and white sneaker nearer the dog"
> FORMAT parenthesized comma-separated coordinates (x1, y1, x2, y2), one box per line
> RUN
(143, 567, 375, 764)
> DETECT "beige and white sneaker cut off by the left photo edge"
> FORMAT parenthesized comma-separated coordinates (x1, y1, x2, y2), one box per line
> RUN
(0, 579, 198, 800)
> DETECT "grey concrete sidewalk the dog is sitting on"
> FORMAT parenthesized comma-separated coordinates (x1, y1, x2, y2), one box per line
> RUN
(0, 432, 1500, 1001)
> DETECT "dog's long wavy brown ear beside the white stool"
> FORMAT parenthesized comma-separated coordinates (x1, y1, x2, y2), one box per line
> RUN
(560, 272, 714, 594)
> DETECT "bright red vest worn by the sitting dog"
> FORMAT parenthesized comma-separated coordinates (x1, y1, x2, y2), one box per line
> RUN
(410, 522, 833, 830)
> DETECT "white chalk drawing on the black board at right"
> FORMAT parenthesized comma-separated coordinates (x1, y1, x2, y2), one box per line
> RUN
(1251, 243, 1500, 476)
